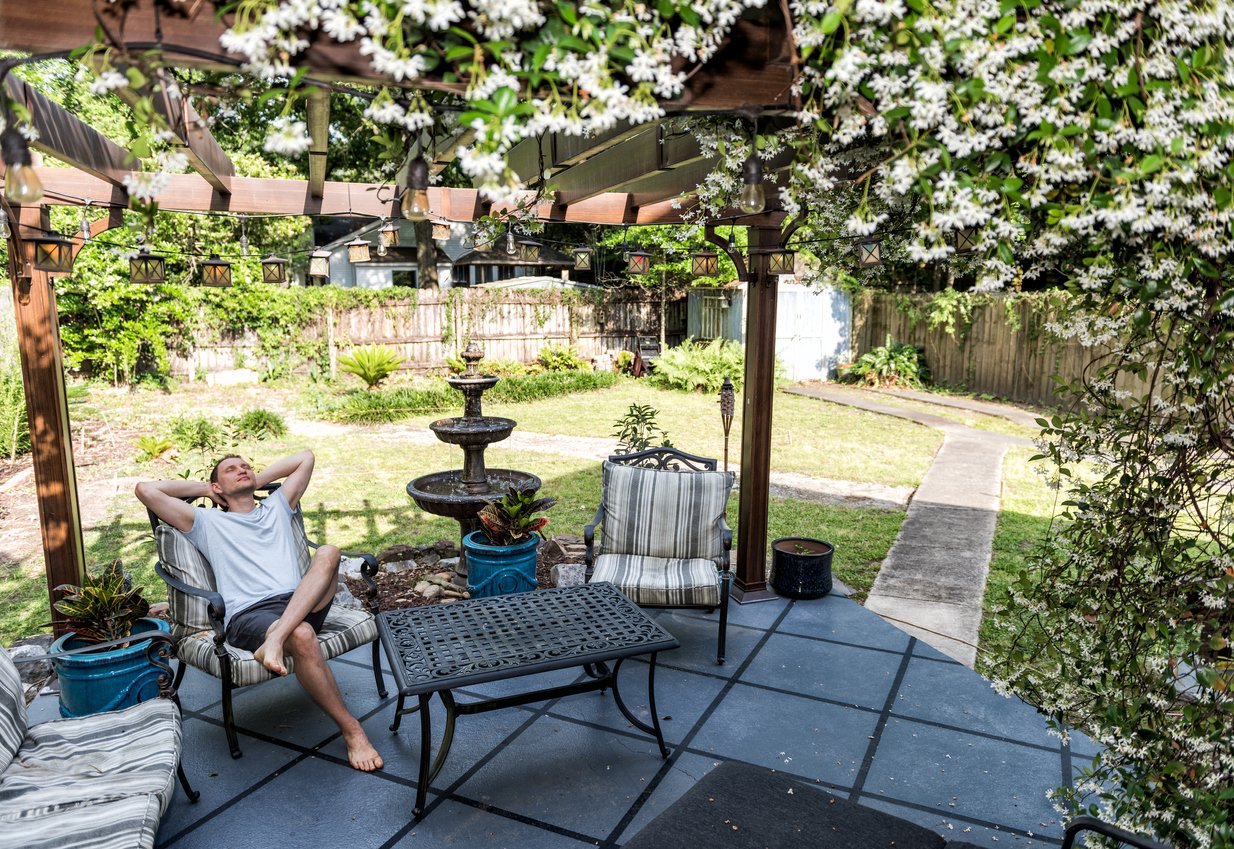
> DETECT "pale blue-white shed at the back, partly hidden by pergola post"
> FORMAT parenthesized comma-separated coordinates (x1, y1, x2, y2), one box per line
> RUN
(686, 276, 853, 380)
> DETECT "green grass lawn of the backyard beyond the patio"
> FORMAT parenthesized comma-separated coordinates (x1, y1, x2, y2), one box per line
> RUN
(0, 381, 940, 643)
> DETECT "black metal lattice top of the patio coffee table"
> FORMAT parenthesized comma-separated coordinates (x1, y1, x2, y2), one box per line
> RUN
(378, 584, 677, 696)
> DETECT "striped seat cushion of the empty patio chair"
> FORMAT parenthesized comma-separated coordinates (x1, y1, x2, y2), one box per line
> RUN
(591, 554, 719, 607)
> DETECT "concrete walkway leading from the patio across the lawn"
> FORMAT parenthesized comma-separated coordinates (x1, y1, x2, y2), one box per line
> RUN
(786, 385, 1032, 666)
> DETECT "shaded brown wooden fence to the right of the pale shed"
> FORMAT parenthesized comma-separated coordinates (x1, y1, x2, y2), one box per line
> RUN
(853, 294, 1143, 405)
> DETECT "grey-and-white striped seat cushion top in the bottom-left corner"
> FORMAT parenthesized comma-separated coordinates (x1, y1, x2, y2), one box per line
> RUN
(0, 698, 180, 824)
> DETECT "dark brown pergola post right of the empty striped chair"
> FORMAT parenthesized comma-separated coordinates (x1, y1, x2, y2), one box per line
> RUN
(733, 227, 780, 601)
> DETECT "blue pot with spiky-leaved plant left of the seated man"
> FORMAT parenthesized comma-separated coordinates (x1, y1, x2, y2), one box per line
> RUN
(49, 560, 169, 717)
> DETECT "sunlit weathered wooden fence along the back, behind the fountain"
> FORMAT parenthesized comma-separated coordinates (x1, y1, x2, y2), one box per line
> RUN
(172, 289, 660, 379)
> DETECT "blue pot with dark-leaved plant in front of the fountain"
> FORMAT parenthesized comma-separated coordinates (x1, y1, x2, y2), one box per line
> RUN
(463, 486, 557, 598)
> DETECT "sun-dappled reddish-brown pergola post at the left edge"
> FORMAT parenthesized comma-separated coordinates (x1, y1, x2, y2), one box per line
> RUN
(9, 206, 85, 624)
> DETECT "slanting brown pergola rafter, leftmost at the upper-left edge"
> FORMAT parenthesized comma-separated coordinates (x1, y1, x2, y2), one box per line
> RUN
(4, 74, 132, 188)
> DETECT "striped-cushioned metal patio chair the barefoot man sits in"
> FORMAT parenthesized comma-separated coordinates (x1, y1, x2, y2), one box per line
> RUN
(148, 484, 386, 758)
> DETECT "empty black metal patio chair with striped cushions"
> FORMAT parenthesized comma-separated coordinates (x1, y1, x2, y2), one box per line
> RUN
(582, 448, 733, 664)
